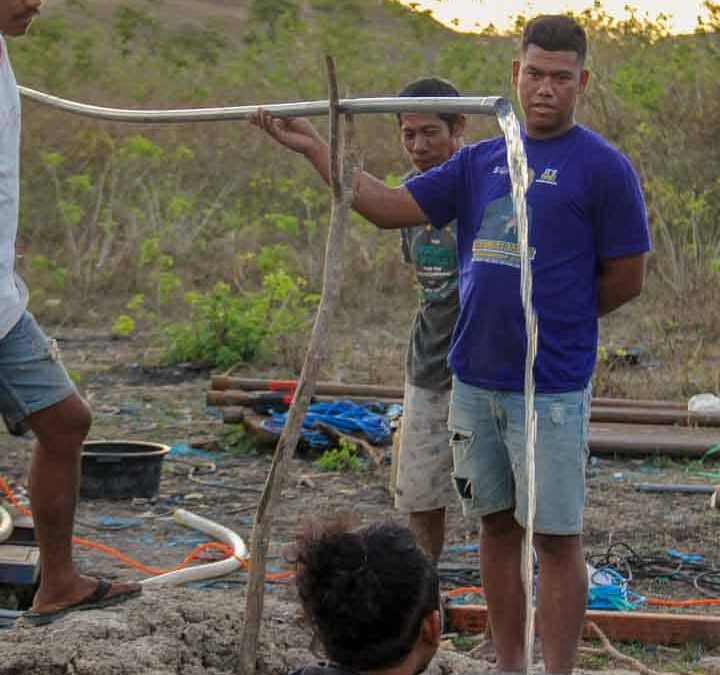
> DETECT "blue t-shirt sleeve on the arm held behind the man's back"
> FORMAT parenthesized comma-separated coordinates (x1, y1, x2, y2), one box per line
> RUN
(593, 152, 650, 260)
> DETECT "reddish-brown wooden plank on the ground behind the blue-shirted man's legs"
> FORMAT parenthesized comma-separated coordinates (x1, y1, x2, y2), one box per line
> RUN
(448, 605, 720, 646)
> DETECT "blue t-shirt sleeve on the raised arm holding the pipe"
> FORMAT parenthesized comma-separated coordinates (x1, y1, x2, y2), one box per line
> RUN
(405, 149, 465, 228)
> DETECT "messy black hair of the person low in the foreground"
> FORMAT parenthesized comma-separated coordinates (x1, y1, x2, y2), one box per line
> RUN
(294, 521, 439, 671)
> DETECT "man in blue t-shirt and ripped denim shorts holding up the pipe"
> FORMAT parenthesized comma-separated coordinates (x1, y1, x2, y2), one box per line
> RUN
(255, 16, 650, 674)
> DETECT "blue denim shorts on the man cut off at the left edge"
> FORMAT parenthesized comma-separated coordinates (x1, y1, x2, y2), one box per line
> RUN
(0, 312, 76, 422)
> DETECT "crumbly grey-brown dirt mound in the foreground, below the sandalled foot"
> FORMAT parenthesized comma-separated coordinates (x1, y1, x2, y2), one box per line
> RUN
(0, 589, 304, 675)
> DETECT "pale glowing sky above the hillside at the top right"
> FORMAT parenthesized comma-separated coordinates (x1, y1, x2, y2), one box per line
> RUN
(400, 0, 706, 33)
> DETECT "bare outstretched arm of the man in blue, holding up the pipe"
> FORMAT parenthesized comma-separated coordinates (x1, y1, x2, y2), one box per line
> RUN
(252, 110, 427, 229)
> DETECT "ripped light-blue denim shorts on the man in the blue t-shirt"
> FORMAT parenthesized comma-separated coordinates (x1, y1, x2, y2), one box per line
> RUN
(448, 378, 591, 535)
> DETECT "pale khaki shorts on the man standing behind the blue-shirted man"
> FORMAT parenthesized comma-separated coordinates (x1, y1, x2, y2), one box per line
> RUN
(395, 382, 458, 513)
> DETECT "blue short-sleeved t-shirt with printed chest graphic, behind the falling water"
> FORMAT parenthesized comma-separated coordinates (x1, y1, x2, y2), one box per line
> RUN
(406, 125, 650, 393)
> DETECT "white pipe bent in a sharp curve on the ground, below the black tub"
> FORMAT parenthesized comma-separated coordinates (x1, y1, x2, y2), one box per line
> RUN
(140, 509, 247, 586)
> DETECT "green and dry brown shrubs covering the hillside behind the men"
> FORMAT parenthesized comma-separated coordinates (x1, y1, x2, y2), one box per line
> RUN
(10, 0, 720, 397)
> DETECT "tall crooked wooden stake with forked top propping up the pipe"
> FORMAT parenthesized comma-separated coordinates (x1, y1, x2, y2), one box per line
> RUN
(239, 56, 358, 675)
